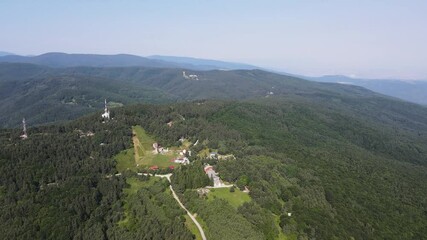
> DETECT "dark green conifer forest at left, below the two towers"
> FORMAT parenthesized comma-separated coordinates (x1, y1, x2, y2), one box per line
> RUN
(0, 114, 130, 239)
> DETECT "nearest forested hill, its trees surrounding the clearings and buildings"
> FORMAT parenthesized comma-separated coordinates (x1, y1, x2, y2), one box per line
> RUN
(0, 94, 427, 240)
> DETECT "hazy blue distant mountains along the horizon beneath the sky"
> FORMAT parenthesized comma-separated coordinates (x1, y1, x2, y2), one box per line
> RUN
(0, 52, 427, 105)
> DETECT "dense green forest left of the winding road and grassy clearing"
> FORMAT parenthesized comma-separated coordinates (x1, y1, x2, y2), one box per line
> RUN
(0, 111, 193, 240)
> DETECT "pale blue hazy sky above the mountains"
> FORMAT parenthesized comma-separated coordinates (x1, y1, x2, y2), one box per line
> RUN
(0, 0, 427, 79)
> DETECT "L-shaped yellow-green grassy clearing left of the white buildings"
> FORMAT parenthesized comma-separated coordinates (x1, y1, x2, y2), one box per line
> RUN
(132, 126, 179, 168)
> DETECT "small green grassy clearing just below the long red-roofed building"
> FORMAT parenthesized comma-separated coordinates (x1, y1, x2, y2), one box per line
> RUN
(208, 188, 251, 209)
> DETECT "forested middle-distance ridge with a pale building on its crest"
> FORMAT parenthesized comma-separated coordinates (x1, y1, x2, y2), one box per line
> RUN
(0, 63, 388, 127)
